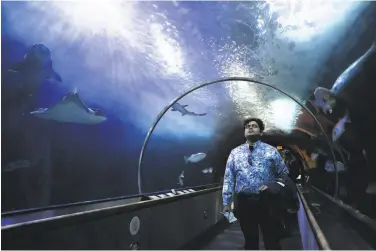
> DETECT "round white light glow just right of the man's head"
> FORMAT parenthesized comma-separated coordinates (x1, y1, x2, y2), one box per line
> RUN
(269, 99, 300, 132)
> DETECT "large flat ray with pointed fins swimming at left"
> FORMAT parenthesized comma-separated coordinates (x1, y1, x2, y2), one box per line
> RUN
(30, 90, 107, 125)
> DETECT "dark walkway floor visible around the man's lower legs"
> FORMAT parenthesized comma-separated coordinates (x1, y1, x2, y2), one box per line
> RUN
(201, 218, 302, 250)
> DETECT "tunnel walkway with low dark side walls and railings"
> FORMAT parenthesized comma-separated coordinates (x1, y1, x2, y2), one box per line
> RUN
(1, 185, 376, 250)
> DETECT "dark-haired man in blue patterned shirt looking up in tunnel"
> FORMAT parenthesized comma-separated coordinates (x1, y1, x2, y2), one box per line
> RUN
(223, 118, 288, 250)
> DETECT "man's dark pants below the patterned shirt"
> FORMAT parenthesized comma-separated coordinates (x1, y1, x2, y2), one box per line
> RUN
(234, 192, 281, 250)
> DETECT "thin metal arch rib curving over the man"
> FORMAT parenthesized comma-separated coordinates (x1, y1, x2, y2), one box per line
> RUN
(137, 77, 338, 198)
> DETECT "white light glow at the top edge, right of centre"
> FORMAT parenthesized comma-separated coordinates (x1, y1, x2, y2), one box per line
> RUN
(267, 0, 354, 41)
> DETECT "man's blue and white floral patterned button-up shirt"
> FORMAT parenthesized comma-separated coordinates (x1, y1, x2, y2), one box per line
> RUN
(222, 141, 289, 205)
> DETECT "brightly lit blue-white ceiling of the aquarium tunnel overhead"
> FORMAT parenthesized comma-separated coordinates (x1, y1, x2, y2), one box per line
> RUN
(3, 1, 369, 136)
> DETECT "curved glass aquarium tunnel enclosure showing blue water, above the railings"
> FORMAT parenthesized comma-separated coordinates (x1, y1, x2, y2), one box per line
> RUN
(1, 1, 376, 226)
